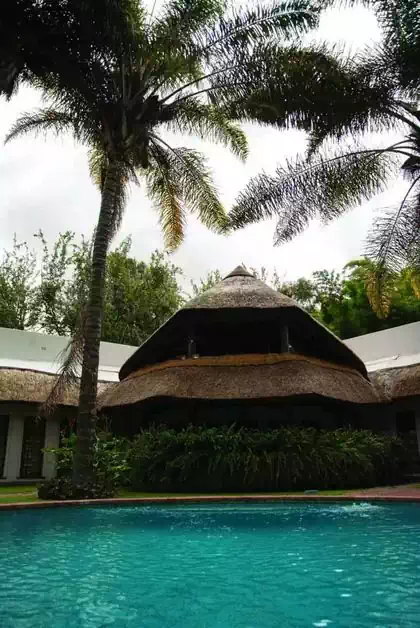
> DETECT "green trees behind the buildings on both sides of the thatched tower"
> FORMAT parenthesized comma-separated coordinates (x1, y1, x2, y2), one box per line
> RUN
(0, 232, 420, 345)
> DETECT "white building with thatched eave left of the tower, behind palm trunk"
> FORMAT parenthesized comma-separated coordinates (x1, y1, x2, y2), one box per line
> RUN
(0, 328, 137, 482)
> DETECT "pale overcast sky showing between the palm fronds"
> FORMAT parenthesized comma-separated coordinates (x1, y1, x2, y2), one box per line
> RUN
(0, 2, 401, 281)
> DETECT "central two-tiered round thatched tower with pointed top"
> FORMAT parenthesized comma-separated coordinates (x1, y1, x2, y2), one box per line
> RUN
(99, 266, 378, 432)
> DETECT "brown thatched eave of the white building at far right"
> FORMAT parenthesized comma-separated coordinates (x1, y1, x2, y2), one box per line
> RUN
(370, 364, 420, 401)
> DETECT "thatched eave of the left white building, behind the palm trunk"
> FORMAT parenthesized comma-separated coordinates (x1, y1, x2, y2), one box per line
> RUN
(0, 368, 108, 407)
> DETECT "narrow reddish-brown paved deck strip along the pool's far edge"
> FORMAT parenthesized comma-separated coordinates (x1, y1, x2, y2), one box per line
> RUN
(0, 485, 420, 510)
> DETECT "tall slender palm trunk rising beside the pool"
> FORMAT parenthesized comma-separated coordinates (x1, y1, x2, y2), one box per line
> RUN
(73, 164, 121, 483)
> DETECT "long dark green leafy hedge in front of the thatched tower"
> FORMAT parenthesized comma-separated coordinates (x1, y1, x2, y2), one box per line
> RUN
(130, 426, 405, 492)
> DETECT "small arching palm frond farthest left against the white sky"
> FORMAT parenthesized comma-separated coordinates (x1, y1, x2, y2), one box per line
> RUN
(5, 109, 75, 143)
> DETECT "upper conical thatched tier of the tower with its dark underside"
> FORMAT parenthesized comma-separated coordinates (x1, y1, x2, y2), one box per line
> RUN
(120, 266, 367, 380)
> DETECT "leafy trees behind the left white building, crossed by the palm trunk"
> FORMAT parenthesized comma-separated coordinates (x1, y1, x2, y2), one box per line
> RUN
(0, 231, 183, 345)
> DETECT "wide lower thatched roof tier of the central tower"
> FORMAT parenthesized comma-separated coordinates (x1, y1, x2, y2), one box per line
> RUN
(99, 353, 378, 409)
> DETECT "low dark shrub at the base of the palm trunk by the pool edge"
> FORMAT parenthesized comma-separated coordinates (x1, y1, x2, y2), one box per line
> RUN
(38, 477, 116, 500)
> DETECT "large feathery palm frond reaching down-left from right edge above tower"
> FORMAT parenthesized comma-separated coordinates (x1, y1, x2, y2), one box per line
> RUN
(230, 147, 397, 244)
